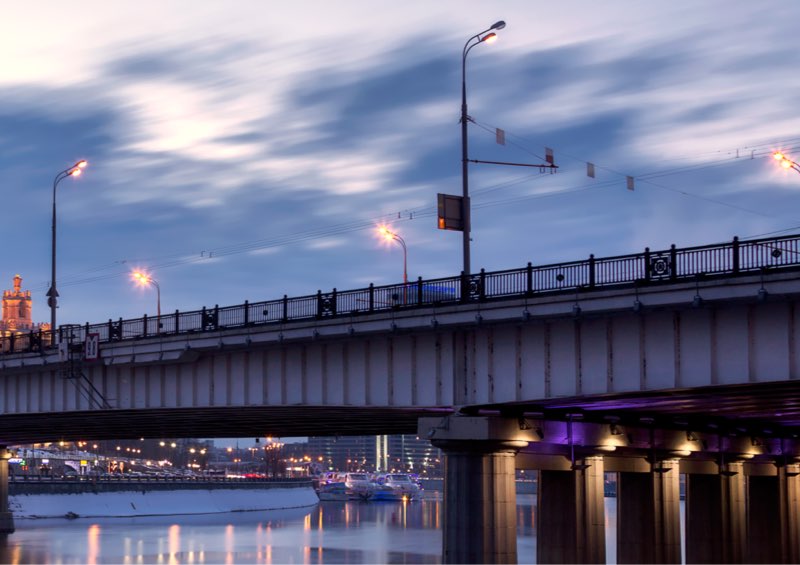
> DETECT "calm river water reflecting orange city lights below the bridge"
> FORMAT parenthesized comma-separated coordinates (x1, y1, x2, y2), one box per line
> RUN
(0, 492, 680, 564)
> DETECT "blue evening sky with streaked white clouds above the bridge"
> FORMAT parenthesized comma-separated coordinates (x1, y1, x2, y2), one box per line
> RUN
(0, 0, 800, 323)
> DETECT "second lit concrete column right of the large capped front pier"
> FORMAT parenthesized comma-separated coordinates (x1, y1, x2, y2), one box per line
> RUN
(617, 459, 681, 563)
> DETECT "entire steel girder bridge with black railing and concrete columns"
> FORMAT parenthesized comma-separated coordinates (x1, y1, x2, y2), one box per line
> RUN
(0, 232, 800, 563)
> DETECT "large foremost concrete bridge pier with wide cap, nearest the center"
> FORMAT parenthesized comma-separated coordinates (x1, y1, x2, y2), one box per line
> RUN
(419, 416, 531, 563)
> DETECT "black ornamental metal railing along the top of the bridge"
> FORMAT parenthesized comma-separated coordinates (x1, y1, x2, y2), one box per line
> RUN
(0, 230, 800, 353)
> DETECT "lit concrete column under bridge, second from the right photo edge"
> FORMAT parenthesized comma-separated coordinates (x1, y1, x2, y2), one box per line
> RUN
(686, 463, 747, 563)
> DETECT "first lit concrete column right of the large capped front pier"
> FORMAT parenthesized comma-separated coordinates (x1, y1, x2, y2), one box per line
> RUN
(536, 457, 606, 563)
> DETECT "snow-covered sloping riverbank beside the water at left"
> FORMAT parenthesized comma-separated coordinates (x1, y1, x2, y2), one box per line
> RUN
(9, 481, 319, 520)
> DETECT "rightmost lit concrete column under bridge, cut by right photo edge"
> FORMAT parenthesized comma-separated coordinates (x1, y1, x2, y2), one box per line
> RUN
(747, 465, 800, 563)
